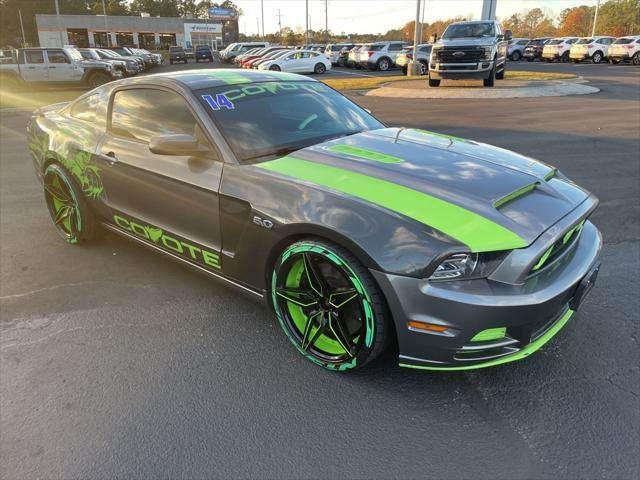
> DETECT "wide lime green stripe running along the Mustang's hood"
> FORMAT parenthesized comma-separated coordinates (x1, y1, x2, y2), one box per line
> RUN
(256, 157, 527, 252)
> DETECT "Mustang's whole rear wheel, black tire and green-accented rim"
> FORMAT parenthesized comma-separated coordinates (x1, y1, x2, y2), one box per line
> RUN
(43, 163, 97, 245)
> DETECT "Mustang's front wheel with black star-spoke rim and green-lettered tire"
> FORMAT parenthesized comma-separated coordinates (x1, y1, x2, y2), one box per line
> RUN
(269, 239, 391, 372)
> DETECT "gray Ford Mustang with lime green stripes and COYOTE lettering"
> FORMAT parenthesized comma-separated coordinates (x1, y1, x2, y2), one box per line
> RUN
(28, 70, 602, 371)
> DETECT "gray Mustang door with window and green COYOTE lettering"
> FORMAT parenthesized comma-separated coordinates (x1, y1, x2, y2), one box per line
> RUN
(99, 86, 223, 272)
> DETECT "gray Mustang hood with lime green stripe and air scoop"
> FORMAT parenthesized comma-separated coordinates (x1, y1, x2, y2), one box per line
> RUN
(258, 128, 589, 251)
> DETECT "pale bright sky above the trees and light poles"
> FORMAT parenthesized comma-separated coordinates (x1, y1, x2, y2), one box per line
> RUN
(234, 0, 597, 35)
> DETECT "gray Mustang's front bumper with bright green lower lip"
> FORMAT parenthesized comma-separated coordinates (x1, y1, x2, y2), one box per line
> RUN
(371, 221, 602, 370)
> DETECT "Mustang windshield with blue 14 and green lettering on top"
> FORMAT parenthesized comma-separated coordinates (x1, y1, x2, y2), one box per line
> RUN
(194, 81, 383, 161)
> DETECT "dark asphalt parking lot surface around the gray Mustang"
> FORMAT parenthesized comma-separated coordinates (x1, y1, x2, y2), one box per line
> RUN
(0, 62, 640, 479)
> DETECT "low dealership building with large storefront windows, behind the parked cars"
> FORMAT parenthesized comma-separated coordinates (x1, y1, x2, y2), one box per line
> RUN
(36, 11, 238, 50)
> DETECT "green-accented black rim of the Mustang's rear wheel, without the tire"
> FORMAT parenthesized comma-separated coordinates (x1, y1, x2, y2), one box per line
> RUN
(44, 167, 82, 243)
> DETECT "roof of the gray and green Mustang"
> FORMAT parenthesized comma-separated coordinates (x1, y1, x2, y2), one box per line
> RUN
(128, 68, 318, 90)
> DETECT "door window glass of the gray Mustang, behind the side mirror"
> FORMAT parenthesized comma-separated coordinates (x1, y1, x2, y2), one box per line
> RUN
(111, 88, 198, 142)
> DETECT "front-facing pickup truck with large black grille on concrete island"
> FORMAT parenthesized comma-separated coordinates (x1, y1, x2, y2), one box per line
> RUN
(429, 21, 511, 87)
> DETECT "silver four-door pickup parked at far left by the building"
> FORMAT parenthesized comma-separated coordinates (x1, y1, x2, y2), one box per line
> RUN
(0, 47, 122, 88)
